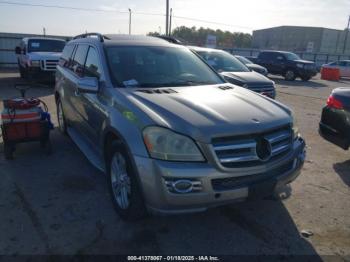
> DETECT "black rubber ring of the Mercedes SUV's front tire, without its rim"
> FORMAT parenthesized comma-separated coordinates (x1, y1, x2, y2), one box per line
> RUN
(106, 141, 147, 221)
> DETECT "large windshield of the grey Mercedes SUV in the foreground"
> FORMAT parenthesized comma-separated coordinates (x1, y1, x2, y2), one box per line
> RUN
(106, 46, 223, 87)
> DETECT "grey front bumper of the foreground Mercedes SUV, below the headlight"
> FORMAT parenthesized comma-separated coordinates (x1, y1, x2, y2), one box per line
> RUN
(134, 138, 305, 214)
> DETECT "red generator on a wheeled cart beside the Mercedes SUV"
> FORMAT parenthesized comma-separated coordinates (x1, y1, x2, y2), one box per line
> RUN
(1, 85, 53, 159)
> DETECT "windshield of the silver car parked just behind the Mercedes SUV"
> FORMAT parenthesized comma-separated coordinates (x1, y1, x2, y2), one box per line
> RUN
(197, 51, 250, 72)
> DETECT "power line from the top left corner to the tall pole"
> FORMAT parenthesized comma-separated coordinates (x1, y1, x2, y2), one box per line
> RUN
(0, 1, 164, 16)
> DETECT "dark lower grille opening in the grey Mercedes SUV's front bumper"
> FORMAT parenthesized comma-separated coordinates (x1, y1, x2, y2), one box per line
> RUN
(211, 161, 294, 191)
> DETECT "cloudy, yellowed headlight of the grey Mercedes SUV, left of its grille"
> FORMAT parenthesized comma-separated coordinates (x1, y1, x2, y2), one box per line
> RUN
(143, 127, 205, 162)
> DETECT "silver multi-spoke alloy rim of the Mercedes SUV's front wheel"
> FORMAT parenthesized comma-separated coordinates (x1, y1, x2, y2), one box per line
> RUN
(111, 153, 131, 209)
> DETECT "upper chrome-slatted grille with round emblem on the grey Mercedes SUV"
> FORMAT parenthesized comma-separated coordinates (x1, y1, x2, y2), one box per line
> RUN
(212, 125, 293, 168)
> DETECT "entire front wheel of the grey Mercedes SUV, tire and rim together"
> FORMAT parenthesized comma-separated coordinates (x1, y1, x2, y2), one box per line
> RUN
(107, 141, 147, 221)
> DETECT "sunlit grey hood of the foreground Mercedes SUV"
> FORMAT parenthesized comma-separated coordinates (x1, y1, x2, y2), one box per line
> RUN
(121, 84, 291, 143)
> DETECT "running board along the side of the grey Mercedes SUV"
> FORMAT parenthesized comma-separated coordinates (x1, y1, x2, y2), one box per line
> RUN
(67, 127, 105, 173)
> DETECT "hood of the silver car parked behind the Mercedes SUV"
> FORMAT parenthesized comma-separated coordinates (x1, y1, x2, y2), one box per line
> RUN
(220, 71, 273, 85)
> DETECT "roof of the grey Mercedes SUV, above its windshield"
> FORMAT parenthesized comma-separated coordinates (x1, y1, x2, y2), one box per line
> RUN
(71, 34, 178, 46)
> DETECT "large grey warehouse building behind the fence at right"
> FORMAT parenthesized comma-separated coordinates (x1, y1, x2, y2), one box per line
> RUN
(252, 26, 350, 55)
